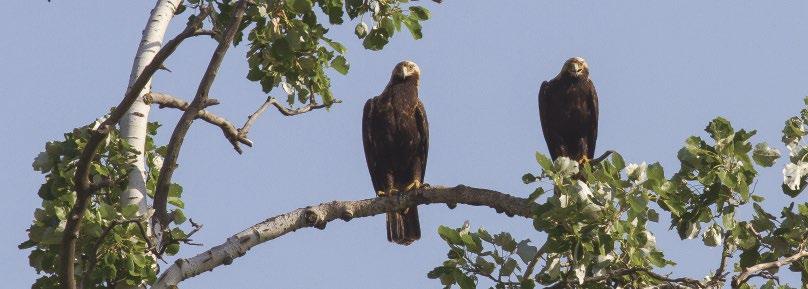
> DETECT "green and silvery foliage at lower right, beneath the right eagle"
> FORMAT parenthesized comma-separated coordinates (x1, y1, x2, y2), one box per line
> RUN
(428, 98, 808, 289)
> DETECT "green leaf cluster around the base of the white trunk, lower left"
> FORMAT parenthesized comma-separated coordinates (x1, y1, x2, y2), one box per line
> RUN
(19, 119, 185, 288)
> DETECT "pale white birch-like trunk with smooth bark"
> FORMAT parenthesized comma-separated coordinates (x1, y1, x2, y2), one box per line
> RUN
(118, 0, 182, 214)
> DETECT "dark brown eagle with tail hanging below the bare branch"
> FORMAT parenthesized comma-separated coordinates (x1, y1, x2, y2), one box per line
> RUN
(362, 61, 429, 245)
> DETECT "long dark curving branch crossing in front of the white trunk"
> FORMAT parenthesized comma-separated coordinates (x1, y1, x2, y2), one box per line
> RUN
(59, 5, 209, 289)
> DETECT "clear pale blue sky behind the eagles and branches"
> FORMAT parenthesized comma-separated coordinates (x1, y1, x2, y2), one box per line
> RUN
(0, 0, 808, 288)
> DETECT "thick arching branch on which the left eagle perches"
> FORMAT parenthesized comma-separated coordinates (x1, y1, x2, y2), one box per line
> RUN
(152, 185, 538, 289)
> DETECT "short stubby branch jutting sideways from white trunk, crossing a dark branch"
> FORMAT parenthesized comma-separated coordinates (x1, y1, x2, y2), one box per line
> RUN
(143, 92, 253, 153)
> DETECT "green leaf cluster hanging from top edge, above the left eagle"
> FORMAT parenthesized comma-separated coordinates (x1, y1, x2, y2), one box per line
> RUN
(188, 0, 430, 106)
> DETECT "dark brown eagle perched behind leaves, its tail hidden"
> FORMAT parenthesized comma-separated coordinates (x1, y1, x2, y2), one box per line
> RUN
(539, 57, 598, 162)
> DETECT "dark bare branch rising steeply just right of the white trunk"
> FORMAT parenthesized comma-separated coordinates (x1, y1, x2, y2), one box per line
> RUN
(152, 0, 247, 239)
